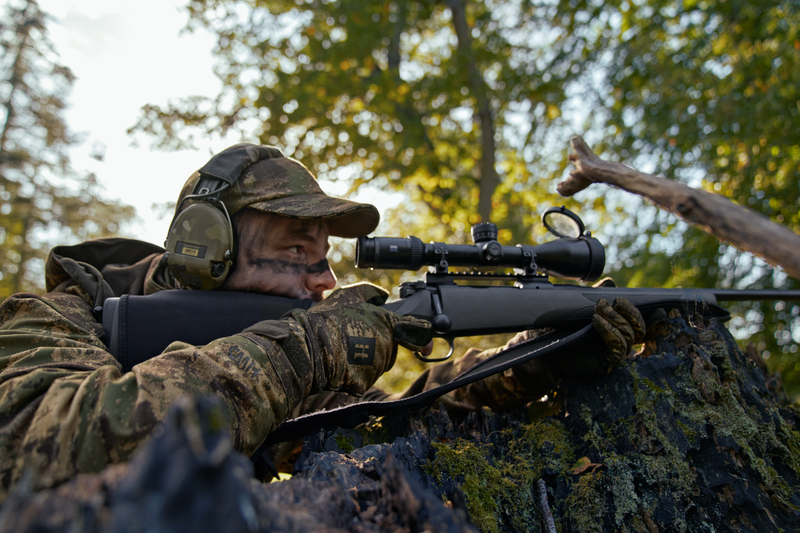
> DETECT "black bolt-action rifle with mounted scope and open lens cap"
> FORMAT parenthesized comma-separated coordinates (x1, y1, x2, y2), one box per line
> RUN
(103, 207, 800, 369)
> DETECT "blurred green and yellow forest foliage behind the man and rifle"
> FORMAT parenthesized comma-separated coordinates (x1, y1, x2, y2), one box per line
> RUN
(0, 0, 800, 396)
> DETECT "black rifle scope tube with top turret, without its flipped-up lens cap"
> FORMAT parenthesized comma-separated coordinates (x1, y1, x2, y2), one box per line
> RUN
(356, 219, 606, 281)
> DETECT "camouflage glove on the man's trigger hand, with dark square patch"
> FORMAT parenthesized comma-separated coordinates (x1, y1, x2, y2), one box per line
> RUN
(284, 283, 433, 396)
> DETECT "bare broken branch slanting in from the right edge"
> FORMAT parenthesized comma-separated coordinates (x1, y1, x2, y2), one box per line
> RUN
(558, 137, 800, 280)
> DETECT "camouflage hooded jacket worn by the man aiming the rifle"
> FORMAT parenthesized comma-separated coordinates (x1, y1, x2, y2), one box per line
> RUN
(0, 239, 552, 494)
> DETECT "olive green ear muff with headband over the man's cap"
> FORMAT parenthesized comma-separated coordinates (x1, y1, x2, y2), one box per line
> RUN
(164, 144, 283, 290)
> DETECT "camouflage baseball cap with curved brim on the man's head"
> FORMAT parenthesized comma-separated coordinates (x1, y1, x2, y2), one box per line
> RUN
(177, 144, 380, 238)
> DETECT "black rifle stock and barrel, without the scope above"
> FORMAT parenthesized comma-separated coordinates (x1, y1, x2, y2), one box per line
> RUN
(103, 282, 800, 371)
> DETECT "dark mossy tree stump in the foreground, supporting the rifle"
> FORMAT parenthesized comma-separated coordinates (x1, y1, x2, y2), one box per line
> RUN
(0, 312, 800, 533)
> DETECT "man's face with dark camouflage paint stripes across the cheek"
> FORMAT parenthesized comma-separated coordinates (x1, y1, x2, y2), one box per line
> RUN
(221, 210, 336, 301)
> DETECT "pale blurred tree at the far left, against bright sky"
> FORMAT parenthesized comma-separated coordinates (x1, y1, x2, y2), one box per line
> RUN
(0, 0, 133, 300)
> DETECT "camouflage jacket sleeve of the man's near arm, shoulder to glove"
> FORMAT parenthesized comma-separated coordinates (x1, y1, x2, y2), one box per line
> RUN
(0, 288, 314, 492)
